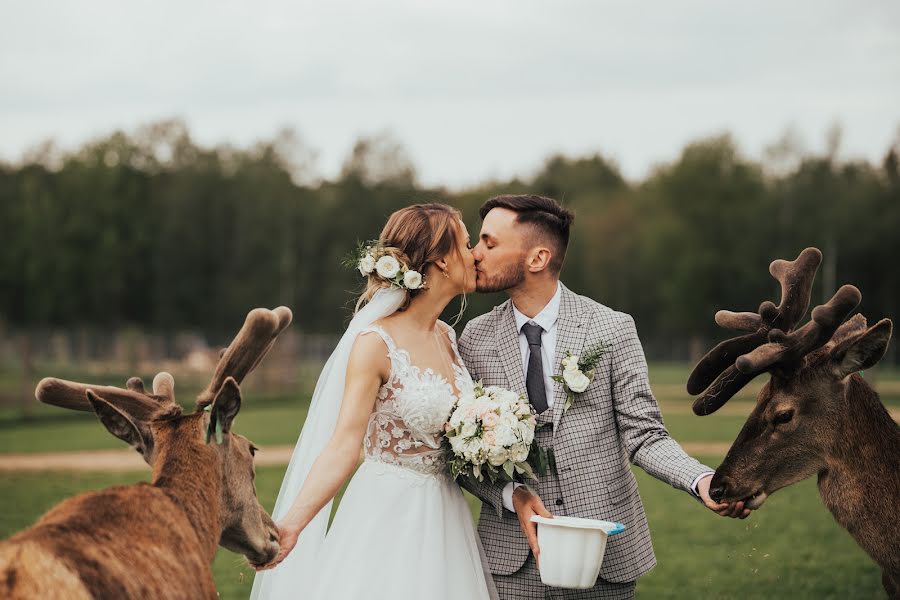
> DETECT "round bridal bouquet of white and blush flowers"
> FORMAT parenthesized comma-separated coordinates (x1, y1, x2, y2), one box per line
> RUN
(444, 382, 547, 483)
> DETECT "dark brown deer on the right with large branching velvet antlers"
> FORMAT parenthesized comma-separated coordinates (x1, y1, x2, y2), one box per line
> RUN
(687, 248, 900, 598)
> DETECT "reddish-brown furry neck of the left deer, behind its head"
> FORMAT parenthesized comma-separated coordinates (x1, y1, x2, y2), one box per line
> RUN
(152, 426, 222, 563)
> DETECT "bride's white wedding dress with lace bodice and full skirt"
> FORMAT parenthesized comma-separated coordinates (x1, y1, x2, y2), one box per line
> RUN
(254, 314, 497, 600)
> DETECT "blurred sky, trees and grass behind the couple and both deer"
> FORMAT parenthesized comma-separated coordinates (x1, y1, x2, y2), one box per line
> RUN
(0, 0, 900, 598)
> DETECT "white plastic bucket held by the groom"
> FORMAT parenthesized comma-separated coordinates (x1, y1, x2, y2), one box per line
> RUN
(531, 515, 625, 589)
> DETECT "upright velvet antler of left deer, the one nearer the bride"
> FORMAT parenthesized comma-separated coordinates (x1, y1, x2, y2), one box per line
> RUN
(197, 306, 293, 409)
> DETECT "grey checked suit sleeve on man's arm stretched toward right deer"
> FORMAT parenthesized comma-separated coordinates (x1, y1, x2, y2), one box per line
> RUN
(611, 315, 713, 493)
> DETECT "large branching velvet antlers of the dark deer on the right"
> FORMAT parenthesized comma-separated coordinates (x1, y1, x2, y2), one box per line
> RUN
(687, 248, 861, 416)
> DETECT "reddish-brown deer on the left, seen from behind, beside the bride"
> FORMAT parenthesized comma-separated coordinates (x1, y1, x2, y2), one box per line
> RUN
(0, 307, 291, 599)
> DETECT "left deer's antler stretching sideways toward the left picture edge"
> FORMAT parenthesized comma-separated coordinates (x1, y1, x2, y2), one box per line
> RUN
(34, 372, 177, 420)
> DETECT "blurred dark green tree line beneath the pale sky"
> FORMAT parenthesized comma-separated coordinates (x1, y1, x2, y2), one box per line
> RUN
(0, 121, 900, 358)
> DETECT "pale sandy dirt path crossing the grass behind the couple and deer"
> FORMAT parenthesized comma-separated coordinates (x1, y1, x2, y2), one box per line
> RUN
(0, 410, 900, 471)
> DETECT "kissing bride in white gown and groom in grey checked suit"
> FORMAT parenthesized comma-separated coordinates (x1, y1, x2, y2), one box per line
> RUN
(251, 195, 750, 600)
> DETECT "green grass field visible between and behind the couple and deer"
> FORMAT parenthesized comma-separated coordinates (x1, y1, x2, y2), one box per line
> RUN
(0, 365, 888, 599)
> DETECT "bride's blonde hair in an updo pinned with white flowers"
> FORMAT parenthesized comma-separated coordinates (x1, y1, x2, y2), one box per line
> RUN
(356, 202, 465, 314)
